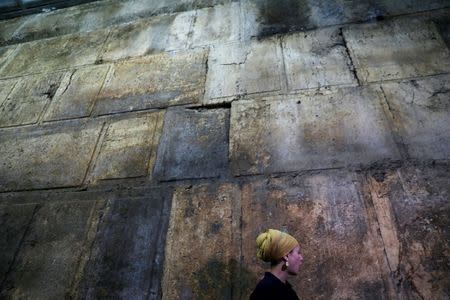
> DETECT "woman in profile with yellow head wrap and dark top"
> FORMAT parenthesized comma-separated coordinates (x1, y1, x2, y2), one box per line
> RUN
(250, 229, 303, 300)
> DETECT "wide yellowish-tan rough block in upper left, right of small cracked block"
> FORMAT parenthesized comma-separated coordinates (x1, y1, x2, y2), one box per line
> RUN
(94, 50, 207, 114)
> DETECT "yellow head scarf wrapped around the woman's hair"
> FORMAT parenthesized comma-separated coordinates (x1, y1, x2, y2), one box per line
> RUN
(256, 229, 298, 262)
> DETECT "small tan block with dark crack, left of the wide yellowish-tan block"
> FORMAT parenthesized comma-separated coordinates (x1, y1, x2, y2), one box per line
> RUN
(44, 65, 109, 121)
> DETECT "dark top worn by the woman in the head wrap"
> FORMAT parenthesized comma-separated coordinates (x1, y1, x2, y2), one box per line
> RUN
(250, 272, 298, 300)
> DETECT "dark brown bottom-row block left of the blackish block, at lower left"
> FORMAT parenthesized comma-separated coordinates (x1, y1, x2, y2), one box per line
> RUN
(0, 201, 101, 299)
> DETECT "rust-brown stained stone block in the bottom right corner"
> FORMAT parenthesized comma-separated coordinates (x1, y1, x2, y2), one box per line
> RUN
(367, 165, 450, 299)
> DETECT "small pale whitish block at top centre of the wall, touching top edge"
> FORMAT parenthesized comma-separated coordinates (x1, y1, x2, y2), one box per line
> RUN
(191, 2, 240, 47)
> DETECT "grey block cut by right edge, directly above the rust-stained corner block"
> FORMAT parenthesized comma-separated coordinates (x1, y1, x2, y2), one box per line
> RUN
(382, 75, 450, 159)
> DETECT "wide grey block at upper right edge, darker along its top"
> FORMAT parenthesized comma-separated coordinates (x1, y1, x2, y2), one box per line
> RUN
(344, 19, 450, 83)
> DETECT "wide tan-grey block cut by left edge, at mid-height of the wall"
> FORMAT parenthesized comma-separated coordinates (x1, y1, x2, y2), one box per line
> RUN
(0, 121, 101, 191)
